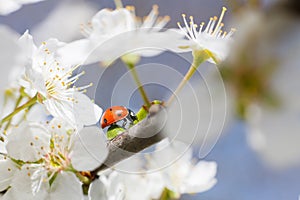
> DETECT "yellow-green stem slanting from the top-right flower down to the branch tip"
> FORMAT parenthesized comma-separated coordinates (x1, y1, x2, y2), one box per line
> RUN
(164, 50, 211, 107)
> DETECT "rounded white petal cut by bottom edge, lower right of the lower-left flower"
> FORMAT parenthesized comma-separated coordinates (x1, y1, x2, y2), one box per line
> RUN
(49, 172, 83, 200)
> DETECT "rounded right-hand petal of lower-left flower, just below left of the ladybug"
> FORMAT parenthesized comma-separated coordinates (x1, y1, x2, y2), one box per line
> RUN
(71, 127, 108, 171)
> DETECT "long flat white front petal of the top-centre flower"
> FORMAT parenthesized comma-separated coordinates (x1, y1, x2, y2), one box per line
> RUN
(87, 30, 179, 63)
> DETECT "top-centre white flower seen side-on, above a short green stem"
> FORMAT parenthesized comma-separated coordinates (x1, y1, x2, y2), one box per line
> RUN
(58, 5, 183, 64)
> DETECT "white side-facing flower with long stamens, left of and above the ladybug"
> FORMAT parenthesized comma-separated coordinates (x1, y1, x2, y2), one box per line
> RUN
(20, 32, 102, 127)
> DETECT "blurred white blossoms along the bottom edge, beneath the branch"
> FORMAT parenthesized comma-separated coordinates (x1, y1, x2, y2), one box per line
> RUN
(89, 140, 217, 200)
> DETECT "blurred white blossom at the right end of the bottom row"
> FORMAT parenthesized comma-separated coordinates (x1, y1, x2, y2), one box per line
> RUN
(149, 140, 217, 197)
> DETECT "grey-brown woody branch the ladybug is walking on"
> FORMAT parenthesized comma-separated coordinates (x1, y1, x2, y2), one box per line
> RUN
(91, 104, 167, 177)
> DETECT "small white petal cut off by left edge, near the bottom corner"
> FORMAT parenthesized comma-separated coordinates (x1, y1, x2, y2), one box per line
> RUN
(0, 159, 17, 191)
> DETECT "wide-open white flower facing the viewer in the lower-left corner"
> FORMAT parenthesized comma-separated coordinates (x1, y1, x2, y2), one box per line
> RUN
(0, 119, 108, 199)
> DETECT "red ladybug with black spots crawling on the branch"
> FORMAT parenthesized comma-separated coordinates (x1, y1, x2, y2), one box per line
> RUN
(101, 106, 137, 128)
